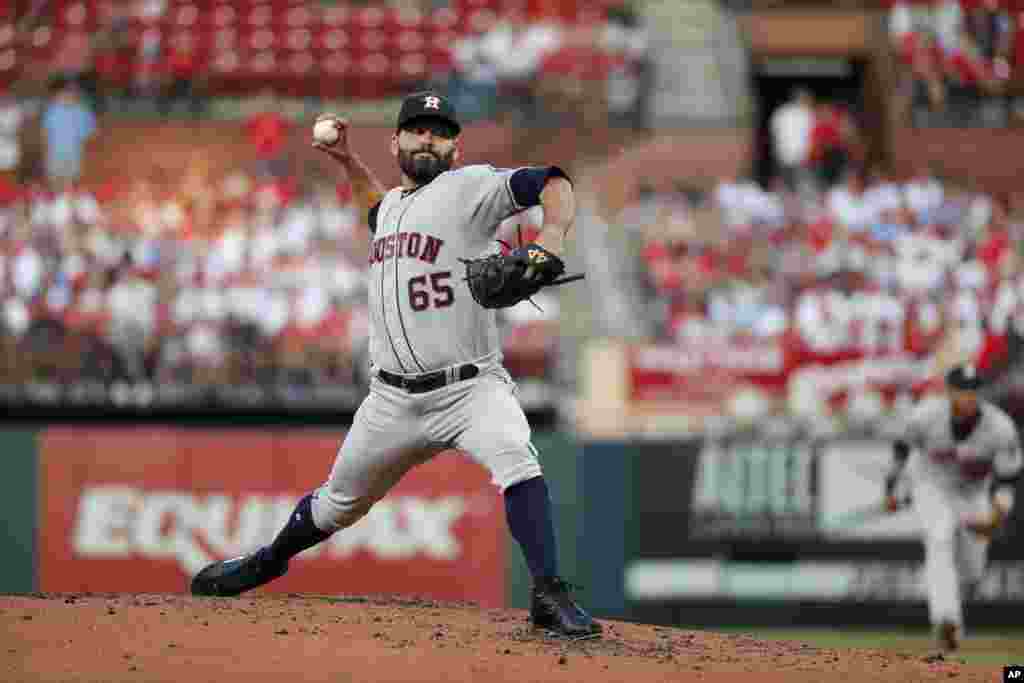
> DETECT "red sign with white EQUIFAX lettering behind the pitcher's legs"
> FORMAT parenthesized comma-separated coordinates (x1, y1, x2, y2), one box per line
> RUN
(39, 428, 506, 606)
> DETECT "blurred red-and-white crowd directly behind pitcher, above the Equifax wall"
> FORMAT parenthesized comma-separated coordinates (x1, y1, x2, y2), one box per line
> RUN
(0, 157, 557, 395)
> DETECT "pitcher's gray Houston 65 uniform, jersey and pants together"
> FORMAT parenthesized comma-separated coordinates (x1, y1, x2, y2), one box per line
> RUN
(312, 166, 541, 529)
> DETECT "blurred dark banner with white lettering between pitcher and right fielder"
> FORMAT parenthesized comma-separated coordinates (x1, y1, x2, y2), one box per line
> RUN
(585, 434, 1024, 625)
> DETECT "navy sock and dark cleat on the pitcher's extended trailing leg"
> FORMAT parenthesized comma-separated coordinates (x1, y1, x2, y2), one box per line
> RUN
(191, 494, 331, 597)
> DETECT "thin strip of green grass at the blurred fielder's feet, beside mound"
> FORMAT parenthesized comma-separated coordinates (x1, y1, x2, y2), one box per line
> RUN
(713, 627, 1024, 667)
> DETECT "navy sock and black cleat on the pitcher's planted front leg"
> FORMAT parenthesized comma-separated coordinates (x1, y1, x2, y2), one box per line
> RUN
(505, 477, 601, 639)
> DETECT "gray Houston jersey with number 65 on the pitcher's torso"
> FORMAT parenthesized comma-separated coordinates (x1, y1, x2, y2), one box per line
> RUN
(369, 166, 523, 375)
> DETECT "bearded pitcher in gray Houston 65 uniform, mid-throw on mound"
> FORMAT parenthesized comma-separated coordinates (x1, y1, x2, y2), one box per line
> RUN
(191, 92, 601, 638)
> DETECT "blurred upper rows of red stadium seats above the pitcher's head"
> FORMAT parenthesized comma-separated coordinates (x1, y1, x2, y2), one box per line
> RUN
(0, 0, 651, 127)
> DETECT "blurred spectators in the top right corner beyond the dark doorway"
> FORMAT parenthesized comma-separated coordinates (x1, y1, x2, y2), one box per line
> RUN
(889, 0, 1024, 127)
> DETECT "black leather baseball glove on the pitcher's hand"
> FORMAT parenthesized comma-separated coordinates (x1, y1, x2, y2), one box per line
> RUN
(460, 243, 583, 308)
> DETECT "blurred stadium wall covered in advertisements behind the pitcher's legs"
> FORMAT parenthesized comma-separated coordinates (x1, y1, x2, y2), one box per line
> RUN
(8, 427, 1024, 626)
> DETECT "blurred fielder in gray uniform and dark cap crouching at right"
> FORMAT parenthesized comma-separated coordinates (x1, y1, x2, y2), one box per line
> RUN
(886, 366, 1021, 651)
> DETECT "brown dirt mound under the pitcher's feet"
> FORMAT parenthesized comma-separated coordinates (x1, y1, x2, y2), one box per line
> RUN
(0, 594, 992, 683)
